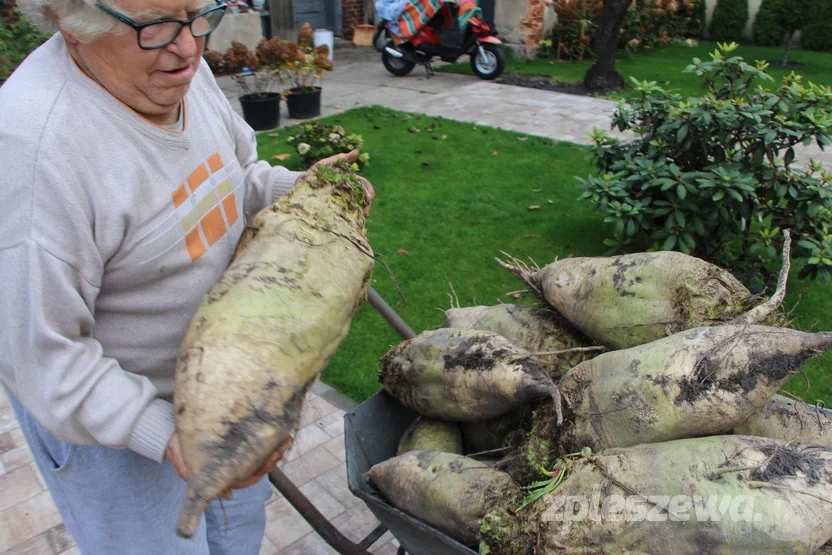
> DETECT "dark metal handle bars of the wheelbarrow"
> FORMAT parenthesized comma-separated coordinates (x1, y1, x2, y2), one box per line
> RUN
(269, 287, 416, 555)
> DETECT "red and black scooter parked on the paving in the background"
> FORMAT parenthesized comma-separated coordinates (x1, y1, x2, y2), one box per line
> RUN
(373, 2, 506, 80)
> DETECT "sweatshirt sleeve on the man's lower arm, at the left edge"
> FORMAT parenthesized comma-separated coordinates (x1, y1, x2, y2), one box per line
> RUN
(0, 239, 174, 462)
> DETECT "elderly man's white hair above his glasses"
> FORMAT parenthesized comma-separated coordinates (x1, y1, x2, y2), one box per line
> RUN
(17, 0, 214, 42)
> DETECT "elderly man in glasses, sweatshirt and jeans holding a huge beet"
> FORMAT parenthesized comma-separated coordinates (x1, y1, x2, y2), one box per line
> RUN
(0, 0, 373, 555)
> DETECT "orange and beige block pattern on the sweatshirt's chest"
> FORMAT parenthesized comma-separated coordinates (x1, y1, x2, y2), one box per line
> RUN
(171, 152, 239, 262)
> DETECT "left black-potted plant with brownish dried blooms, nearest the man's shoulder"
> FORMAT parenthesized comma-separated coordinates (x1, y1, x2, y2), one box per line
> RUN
(205, 39, 283, 131)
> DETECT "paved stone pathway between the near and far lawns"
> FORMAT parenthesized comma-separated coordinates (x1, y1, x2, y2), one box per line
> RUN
(219, 41, 832, 169)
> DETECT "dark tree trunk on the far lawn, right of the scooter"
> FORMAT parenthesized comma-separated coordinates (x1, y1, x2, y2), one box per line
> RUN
(584, 0, 633, 91)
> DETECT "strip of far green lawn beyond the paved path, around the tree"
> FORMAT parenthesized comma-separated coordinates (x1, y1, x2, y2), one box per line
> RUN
(437, 42, 832, 102)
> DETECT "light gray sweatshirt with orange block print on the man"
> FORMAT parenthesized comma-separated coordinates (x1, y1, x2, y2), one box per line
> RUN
(0, 34, 299, 461)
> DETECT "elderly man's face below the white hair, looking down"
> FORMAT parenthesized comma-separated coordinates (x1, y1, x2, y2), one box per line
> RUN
(66, 0, 214, 124)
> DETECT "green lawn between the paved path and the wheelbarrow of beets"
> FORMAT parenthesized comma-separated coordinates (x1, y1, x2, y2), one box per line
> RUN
(259, 108, 832, 408)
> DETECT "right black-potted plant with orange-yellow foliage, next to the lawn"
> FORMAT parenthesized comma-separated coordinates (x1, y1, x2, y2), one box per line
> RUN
(281, 23, 333, 119)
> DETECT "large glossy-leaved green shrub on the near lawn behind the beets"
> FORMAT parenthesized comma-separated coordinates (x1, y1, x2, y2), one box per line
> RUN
(581, 44, 832, 289)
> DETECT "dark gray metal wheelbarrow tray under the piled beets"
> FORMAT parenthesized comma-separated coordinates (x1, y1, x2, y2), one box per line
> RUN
(344, 391, 477, 555)
